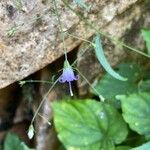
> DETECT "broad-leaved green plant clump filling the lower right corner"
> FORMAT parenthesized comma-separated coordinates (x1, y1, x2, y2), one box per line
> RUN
(52, 63, 150, 150)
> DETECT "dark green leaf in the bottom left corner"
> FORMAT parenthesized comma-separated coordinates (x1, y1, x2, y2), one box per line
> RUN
(4, 133, 31, 150)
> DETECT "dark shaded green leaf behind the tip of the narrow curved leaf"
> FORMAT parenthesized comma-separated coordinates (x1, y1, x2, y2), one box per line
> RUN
(92, 63, 142, 101)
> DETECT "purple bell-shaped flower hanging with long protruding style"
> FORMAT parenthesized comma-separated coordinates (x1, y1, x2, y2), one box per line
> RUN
(59, 60, 78, 96)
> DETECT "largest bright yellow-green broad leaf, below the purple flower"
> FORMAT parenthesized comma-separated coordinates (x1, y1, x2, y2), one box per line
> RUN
(52, 100, 128, 150)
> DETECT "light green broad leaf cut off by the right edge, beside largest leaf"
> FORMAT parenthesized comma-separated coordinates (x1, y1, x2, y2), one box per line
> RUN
(120, 92, 150, 136)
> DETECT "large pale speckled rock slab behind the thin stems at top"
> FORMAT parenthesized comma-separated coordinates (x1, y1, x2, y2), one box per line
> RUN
(0, 0, 141, 88)
